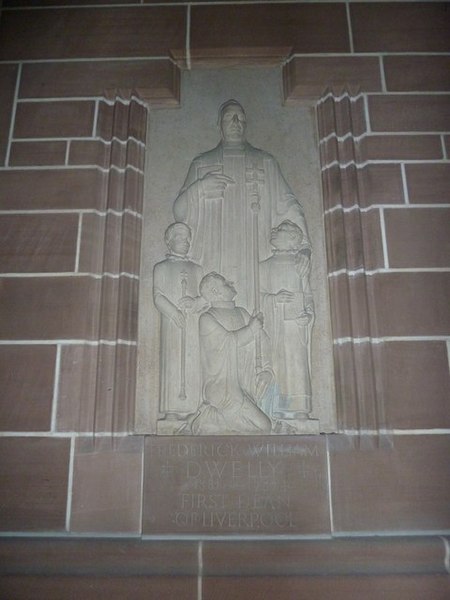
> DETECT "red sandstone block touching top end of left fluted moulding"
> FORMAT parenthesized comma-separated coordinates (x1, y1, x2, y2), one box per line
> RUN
(13, 101, 95, 138)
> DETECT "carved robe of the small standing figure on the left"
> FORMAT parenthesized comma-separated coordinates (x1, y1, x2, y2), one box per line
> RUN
(153, 254, 203, 418)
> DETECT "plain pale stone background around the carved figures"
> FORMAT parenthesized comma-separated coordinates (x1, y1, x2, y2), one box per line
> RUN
(135, 66, 336, 433)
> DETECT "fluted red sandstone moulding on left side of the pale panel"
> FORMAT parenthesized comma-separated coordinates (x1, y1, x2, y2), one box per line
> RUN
(79, 98, 147, 434)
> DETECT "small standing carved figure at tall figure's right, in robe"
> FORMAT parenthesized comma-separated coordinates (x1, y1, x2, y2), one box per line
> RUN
(260, 220, 314, 419)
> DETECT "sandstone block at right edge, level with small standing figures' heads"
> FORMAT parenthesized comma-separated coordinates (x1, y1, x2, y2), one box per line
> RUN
(384, 208, 450, 268)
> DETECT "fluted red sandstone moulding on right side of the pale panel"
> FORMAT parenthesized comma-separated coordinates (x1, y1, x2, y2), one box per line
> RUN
(317, 91, 386, 432)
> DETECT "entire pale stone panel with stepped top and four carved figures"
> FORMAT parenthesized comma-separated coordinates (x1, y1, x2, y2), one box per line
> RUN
(135, 67, 336, 436)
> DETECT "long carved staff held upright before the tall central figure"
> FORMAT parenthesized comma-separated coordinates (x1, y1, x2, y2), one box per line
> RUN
(246, 165, 264, 374)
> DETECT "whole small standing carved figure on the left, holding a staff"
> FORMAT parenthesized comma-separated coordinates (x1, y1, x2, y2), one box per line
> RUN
(153, 223, 205, 419)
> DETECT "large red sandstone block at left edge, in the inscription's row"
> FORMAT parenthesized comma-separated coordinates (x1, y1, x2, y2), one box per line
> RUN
(0, 437, 70, 532)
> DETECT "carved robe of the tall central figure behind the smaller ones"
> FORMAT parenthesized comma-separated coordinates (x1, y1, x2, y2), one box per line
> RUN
(174, 142, 310, 312)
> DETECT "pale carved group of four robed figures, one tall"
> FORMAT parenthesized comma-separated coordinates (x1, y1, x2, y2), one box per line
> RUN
(154, 100, 319, 434)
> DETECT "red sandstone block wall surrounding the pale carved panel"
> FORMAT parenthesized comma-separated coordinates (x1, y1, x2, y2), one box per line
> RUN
(0, 0, 450, 600)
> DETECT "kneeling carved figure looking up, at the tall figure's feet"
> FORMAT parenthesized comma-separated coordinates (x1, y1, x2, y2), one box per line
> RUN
(191, 272, 272, 434)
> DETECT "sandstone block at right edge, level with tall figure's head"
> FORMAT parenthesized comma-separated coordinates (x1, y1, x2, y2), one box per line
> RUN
(368, 94, 450, 132)
